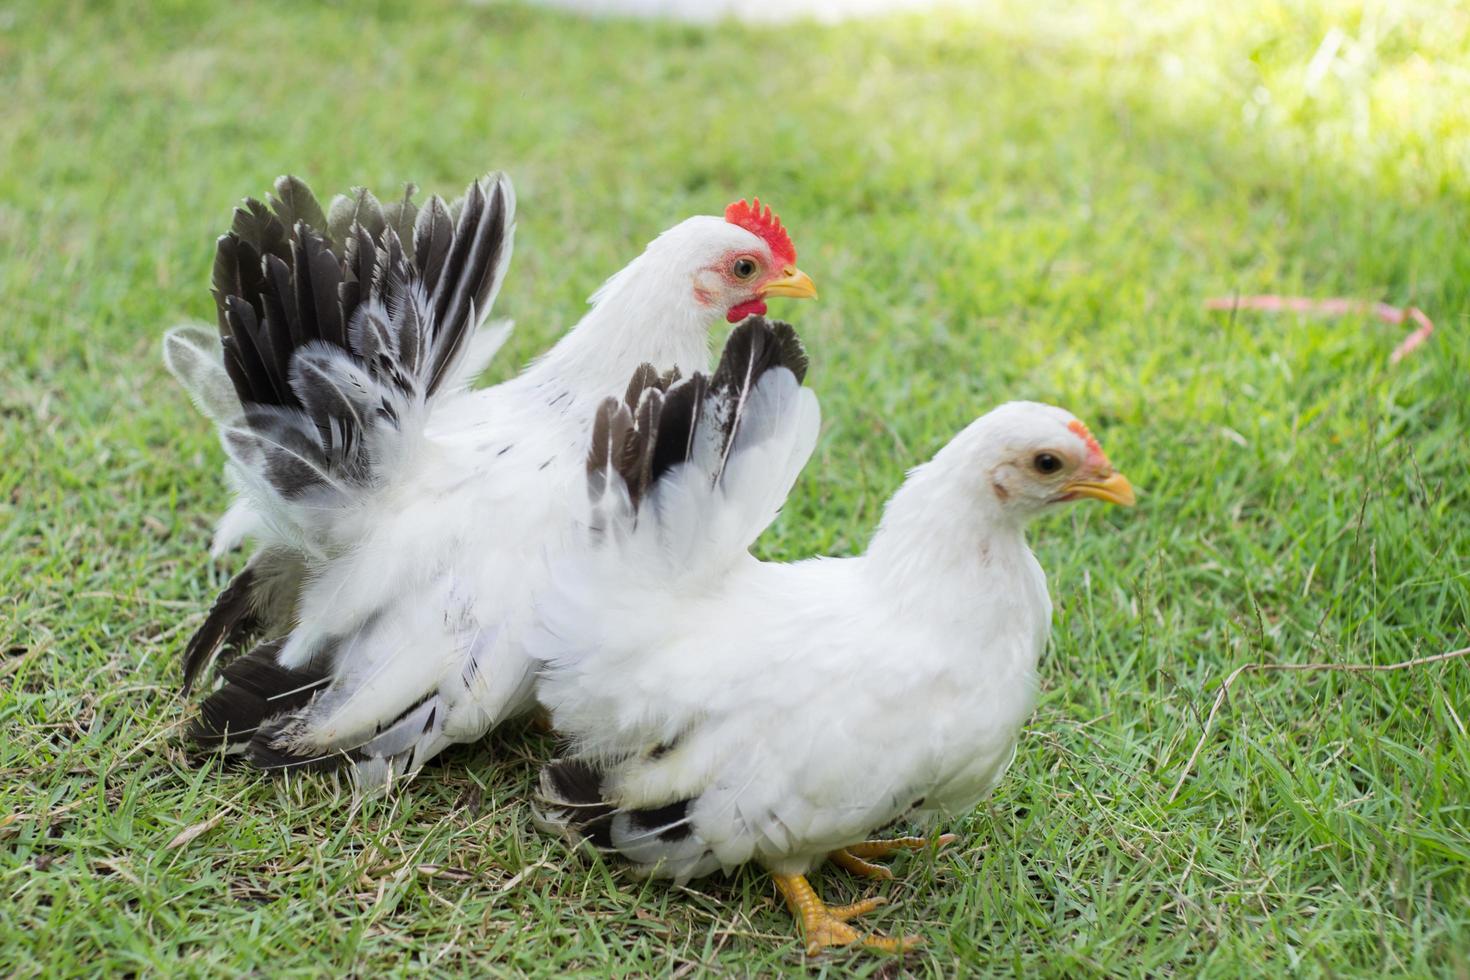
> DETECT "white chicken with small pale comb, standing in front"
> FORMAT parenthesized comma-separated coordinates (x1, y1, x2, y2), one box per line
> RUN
(532, 320, 1133, 952)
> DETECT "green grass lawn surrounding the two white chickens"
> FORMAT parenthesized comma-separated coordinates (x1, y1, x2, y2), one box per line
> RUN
(0, 0, 1470, 977)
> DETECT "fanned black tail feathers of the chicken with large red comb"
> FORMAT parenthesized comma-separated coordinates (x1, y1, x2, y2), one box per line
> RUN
(204, 176, 513, 497)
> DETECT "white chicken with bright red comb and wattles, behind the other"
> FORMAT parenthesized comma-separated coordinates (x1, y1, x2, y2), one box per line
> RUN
(165, 175, 814, 789)
